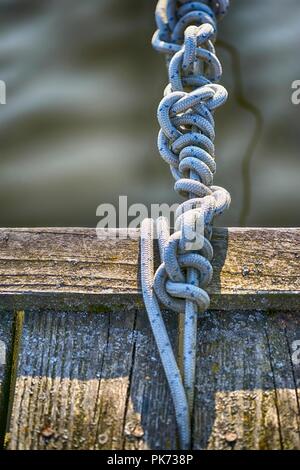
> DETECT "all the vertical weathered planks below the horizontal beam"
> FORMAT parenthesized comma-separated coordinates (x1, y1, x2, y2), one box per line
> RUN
(3, 310, 300, 450)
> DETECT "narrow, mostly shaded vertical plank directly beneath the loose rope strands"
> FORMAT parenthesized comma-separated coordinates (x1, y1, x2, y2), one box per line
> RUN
(124, 312, 178, 450)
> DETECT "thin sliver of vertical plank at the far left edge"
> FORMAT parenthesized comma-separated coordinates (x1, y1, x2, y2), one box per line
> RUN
(0, 311, 14, 448)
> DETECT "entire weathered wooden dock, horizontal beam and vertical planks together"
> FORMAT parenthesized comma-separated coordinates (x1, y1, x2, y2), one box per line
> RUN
(0, 229, 300, 450)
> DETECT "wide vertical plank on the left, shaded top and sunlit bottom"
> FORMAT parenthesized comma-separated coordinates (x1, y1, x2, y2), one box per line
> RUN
(8, 312, 113, 449)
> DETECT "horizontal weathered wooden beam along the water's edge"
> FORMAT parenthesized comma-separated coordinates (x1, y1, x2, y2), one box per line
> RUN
(0, 228, 300, 312)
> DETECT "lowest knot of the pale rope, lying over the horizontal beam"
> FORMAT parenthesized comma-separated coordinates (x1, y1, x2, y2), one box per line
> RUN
(153, 186, 230, 313)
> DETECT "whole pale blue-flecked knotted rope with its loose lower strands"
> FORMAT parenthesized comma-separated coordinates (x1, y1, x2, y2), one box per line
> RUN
(141, 0, 230, 449)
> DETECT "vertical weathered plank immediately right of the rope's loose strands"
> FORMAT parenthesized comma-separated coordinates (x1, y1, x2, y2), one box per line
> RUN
(194, 312, 284, 450)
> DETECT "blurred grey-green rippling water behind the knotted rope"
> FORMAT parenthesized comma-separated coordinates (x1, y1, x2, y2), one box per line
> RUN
(0, 0, 300, 226)
